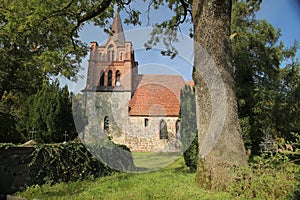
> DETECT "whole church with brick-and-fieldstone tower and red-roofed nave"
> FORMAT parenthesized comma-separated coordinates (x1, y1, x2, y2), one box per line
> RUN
(84, 13, 192, 152)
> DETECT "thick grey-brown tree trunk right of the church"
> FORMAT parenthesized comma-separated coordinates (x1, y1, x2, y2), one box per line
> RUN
(193, 0, 247, 189)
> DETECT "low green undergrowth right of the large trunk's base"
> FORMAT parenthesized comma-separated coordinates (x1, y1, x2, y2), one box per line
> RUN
(230, 153, 300, 199)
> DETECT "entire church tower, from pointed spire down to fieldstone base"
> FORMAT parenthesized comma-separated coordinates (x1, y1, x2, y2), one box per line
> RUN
(85, 12, 138, 143)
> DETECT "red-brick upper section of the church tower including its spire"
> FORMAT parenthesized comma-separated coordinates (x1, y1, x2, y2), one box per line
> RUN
(86, 12, 138, 93)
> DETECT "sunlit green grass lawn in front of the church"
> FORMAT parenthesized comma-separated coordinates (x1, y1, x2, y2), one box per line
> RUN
(15, 156, 232, 200)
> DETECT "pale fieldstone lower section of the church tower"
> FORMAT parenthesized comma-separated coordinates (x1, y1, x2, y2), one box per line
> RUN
(84, 92, 131, 144)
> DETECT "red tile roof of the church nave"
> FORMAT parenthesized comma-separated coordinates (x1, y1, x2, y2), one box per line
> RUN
(129, 74, 185, 116)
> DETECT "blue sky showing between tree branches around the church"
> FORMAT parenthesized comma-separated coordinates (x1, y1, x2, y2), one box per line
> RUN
(68, 0, 300, 93)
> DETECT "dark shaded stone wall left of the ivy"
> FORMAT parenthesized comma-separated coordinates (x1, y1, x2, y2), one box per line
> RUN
(0, 147, 34, 195)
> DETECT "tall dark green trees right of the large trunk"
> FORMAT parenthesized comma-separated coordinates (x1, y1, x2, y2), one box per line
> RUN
(231, 0, 300, 154)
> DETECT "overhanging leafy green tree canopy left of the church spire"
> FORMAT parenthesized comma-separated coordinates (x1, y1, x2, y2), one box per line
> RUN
(0, 0, 116, 96)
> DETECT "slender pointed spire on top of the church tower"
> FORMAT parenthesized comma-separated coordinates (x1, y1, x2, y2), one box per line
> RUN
(111, 11, 125, 46)
